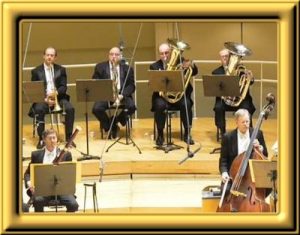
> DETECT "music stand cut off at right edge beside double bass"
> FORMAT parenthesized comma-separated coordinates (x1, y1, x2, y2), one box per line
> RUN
(249, 159, 277, 212)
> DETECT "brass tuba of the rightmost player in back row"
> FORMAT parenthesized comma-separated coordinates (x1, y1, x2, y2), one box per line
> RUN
(222, 42, 252, 107)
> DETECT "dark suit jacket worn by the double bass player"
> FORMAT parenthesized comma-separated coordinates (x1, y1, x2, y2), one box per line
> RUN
(219, 128, 268, 174)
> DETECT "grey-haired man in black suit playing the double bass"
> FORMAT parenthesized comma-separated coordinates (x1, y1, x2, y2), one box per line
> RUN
(219, 109, 268, 182)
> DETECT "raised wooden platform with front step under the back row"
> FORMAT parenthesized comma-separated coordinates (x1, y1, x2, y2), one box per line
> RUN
(22, 117, 278, 177)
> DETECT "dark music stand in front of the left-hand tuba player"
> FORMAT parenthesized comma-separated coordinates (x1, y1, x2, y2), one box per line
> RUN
(148, 70, 184, 153)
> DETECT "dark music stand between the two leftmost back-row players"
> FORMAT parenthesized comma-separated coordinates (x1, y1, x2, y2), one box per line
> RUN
(76, 79, 114, 161)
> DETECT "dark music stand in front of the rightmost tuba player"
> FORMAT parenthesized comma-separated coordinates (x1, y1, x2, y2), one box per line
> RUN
(203, 75, 240, 154)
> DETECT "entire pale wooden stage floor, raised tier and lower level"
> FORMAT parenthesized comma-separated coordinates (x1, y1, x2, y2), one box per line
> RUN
(20, 118, 277, 214)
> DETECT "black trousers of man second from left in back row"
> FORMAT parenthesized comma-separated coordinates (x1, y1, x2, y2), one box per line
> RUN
(92, 97, 136, 131)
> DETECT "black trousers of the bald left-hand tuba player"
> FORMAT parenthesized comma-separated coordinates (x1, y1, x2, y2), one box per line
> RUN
(152, 96, 193, 134)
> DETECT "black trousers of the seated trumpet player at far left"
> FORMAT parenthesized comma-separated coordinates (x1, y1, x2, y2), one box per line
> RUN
(29, 99, 75, 141)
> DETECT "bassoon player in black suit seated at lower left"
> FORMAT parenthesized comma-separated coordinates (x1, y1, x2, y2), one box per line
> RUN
(24, 129, 79, 212)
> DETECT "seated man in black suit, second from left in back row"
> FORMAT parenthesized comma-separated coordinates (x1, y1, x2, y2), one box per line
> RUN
(93, 47, 136, 138)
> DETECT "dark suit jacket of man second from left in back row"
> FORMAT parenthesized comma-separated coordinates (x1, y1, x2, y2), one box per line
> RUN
(93, 61, 135, 97)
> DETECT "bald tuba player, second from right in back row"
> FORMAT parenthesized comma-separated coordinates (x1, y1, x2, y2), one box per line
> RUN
(150, 43, 198, 146)
